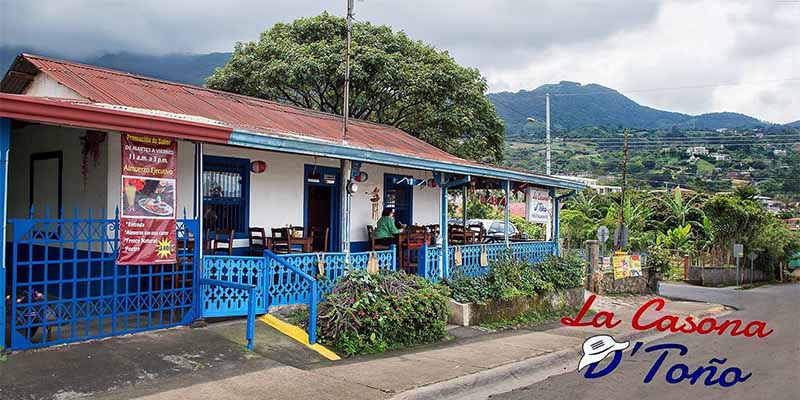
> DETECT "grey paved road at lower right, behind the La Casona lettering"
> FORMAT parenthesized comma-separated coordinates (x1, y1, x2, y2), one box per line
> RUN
(491, 284, 800, 400)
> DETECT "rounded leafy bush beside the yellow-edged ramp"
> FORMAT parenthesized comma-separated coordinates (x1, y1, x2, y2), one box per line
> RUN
(317, 271, 449, 355)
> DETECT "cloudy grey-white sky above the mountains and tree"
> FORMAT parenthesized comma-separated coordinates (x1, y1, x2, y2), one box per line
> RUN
(0, 0, 800, 122)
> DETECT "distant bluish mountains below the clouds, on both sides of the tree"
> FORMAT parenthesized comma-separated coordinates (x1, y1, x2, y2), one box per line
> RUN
(0, 46, 800, 131)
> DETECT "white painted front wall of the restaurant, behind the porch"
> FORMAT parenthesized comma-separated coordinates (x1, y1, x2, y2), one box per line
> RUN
(8, 125, 440, 250)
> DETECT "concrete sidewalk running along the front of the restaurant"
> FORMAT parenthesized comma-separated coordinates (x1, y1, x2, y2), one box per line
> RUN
(0, 297, 722, 400)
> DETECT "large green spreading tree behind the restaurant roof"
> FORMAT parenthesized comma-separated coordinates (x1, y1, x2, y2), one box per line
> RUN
(206, 13, 503, 162)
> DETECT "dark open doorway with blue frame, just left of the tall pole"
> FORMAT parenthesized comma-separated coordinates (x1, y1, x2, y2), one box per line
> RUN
(303, 165, 341, 252)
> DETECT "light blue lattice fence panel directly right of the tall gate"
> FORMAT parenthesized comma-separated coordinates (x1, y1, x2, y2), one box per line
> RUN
(200, 256, 268, 317)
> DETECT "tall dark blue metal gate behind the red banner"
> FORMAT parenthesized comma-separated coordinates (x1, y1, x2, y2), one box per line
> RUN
(5, 209, 202, 349)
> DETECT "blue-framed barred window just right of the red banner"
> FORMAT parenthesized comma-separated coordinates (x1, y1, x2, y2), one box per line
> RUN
(203, 156, 250, 237)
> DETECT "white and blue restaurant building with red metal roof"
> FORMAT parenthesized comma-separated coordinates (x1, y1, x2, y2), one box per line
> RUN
(0, 54, 584, 349)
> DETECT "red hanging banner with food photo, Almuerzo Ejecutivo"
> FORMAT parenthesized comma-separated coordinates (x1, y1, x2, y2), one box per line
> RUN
(117, 133, 178, 265)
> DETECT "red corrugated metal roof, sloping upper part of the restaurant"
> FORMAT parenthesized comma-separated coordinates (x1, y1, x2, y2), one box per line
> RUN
(18, 54, 466, 163)
